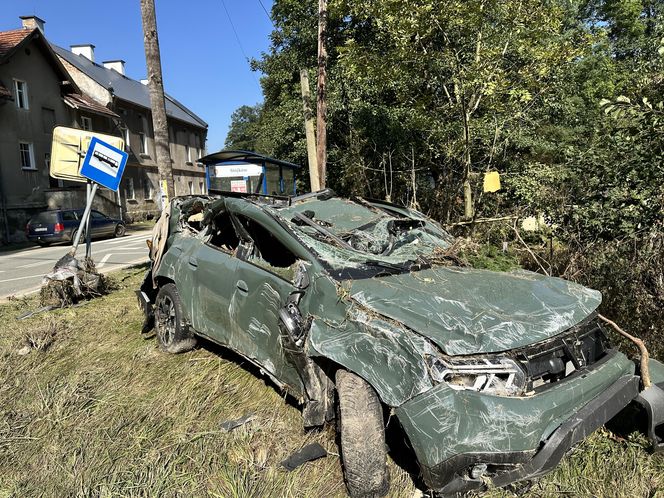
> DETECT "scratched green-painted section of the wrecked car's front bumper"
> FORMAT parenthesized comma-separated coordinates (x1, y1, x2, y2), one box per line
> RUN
(395, 353, 634, 467)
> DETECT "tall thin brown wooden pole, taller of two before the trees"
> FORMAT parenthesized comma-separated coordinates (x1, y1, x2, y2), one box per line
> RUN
(316, 0, 327, 188)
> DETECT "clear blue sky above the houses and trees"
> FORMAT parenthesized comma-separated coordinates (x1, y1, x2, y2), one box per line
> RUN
(0, 0, 272, 152)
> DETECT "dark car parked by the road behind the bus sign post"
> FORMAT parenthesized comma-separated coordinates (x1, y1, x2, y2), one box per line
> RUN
(25, 209, 126, 246)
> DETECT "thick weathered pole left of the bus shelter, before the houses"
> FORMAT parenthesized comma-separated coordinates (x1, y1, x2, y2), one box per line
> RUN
(141, 0, 175, 209)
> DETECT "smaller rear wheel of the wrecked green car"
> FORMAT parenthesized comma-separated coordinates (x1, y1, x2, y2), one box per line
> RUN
(154, 284, 196, 353)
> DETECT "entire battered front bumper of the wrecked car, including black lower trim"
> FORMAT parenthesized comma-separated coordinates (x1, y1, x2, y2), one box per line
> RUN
(396, 351, 664, 494)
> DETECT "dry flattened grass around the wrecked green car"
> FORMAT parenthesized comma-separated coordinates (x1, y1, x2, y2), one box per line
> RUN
(0, 270, 664, 497)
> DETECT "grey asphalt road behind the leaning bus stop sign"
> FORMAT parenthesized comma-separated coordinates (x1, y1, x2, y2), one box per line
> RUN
(0, 230, 150, 299)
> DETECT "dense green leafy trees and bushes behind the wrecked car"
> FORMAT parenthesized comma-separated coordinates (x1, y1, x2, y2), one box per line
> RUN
(231, 0, 664, 342)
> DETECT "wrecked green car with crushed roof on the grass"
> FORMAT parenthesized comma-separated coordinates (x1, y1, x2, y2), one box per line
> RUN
(138, 190, 664, 496)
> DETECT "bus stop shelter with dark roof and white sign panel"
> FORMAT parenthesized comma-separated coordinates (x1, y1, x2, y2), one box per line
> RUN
(199, 150, 300, 195)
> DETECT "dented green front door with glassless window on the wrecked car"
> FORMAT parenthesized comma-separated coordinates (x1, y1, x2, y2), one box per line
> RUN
(223, 215, 302, 392)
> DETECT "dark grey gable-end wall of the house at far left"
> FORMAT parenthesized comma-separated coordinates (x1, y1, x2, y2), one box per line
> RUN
(0, 36, 71, 240)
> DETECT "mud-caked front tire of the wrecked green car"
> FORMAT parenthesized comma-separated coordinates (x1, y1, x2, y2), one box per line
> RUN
(336, 370, 390, 498)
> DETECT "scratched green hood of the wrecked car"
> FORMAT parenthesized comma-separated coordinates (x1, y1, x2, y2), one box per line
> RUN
(346, 267, 602, 355)
